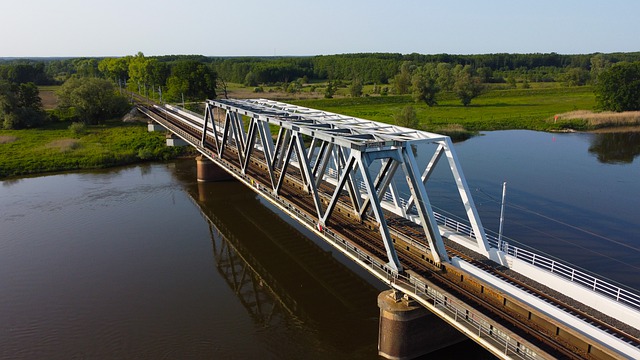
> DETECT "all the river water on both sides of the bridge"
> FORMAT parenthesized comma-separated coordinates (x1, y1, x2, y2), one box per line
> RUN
(0, 131, 640, 359)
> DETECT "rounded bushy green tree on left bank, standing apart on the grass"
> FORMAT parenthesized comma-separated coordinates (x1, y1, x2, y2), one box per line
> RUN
(58, 77, 129, 124)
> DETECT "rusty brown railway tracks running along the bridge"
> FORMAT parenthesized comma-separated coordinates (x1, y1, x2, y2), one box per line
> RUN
(138, 101, 640, 359)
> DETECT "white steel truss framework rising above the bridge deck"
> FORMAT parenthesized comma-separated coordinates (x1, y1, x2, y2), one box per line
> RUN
(201, 99, 490, 271)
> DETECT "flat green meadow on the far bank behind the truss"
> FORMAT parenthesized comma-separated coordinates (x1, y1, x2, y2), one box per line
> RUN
(291, 86, 595, 131)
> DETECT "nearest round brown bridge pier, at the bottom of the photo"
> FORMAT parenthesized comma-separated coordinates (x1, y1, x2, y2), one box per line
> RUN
(378, 290, 466, 360)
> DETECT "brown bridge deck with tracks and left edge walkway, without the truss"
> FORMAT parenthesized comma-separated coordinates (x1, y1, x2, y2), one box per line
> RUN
(139, 99, 639, 358)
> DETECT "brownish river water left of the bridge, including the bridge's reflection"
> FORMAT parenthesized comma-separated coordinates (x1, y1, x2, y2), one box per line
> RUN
(0, 160, 487, 359)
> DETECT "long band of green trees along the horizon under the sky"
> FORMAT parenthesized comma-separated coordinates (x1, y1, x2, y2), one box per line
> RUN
(0, 52, 640, 128)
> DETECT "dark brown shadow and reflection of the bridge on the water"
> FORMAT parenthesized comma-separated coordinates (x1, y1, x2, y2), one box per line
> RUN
(170, 161, 493, 359)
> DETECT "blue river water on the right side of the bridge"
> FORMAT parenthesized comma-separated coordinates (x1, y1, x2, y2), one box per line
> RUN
(428, 131, 640, 289)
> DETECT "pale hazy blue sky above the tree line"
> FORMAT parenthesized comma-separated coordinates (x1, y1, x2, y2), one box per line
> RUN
(0, 0, 640, 57)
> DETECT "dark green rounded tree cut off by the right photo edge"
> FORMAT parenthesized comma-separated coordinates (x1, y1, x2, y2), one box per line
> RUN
(594, 61, 640, 112)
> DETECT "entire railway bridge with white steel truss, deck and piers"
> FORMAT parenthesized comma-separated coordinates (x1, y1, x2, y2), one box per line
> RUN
(138, 99, 640, 359)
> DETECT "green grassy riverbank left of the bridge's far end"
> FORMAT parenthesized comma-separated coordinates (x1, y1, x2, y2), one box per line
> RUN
(0, 120, 190, 178)
